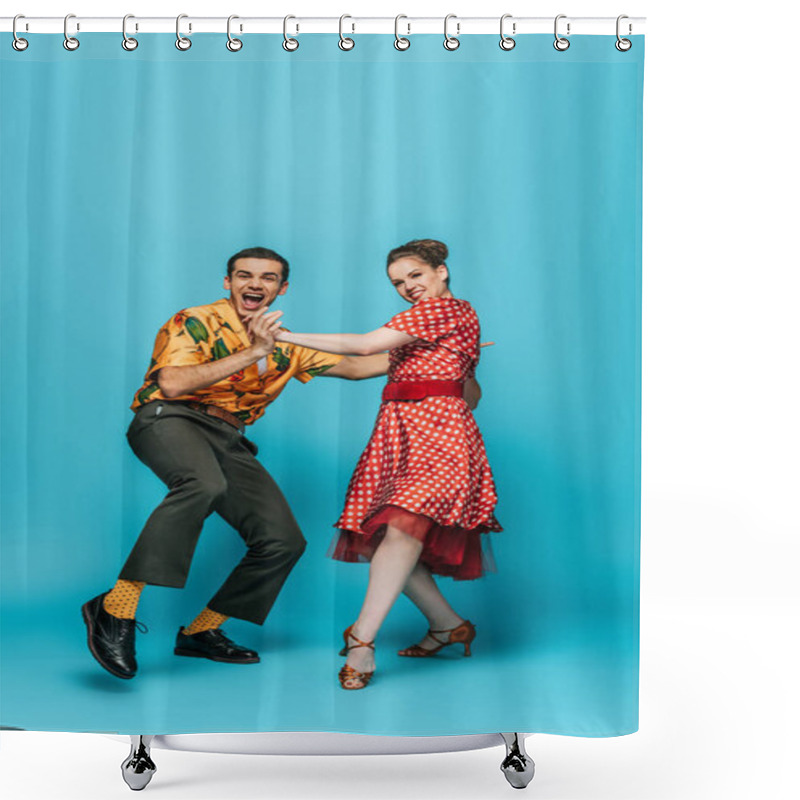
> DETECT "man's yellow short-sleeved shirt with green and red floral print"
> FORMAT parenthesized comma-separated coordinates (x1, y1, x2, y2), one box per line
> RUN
(131, 298, 342, 425)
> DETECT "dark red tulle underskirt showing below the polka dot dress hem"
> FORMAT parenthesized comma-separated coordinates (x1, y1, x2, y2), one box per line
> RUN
(328, 505, 496, 581)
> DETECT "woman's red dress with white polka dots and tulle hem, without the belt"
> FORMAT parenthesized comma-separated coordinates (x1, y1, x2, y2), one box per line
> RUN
(330, 297, 502, 580)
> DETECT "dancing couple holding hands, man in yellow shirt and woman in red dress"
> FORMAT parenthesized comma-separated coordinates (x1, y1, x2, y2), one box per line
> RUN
(82, 240, 501, 689)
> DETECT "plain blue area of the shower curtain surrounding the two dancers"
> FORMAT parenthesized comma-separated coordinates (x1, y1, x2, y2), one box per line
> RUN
(0, 33, 644, 736)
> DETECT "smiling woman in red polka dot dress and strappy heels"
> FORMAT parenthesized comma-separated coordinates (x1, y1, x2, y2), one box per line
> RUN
(266, 239, 502, 689)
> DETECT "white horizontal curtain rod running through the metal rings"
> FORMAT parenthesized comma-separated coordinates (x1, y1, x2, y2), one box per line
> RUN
(0, 15, 645, 35)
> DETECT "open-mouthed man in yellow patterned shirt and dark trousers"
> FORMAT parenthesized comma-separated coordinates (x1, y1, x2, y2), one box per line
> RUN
(82, 247, 388, 678)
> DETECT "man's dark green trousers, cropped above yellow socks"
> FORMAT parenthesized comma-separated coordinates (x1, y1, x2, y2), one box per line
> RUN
(119, 400, 306, 624)
